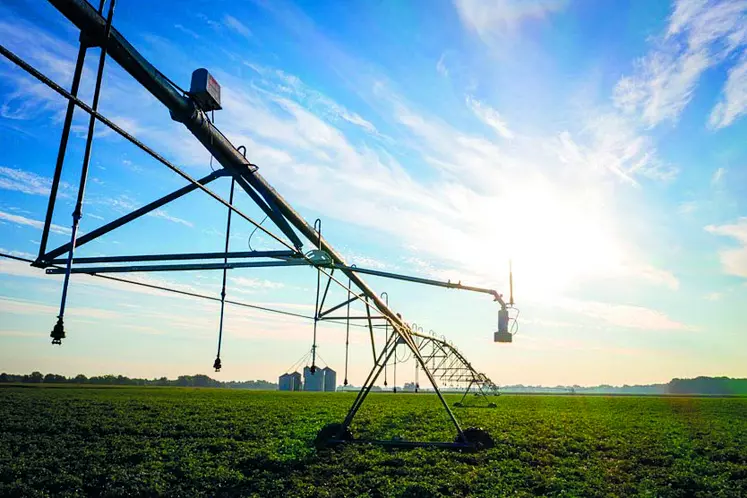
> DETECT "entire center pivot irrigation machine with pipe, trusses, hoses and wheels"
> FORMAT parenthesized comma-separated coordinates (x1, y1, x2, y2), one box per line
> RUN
(0, 0, 518, 450)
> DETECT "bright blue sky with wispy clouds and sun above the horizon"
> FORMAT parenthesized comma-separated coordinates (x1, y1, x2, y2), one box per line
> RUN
(0, 0, 747, 385)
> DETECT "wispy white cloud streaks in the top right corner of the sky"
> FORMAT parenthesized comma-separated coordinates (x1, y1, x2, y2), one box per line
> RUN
(614, 0, 747, 128)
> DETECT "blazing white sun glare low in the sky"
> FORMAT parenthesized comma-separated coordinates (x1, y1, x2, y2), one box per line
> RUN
(477, 177, 624, 297)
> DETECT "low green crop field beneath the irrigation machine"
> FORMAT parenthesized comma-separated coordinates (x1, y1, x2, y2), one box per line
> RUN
(0, 387, 747, 497)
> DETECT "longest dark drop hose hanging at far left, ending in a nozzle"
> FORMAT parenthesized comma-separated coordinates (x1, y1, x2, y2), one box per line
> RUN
(50, 0, 115, 344)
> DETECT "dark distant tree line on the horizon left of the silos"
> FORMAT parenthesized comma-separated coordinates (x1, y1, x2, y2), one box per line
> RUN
(0, 372, 278, 390)
